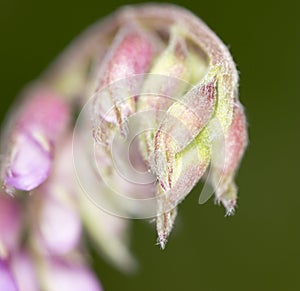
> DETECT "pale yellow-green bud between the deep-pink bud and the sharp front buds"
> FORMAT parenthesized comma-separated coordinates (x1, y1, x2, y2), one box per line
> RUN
(137, 28, 191, 161)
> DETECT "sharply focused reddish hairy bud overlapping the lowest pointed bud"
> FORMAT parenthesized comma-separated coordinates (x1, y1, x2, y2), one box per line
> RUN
(152, 77, 216, 191)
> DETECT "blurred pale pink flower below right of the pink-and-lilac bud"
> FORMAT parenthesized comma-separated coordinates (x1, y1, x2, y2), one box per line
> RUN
(29, 134, 82, 255)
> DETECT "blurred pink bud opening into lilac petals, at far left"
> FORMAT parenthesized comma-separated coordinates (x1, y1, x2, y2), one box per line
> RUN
(4, 89, 69, 191)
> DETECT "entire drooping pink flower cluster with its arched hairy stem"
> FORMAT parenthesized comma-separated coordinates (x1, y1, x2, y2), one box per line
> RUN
(0, 4, 247, 291)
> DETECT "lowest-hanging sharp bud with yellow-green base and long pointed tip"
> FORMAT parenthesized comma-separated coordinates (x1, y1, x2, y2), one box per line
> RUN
(156, 128, 211, 249)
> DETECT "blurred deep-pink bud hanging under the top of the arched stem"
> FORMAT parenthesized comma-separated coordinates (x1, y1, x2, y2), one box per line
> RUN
(94, 25, 156, 143)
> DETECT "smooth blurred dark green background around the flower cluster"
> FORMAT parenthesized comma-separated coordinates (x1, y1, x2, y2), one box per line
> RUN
(0, 0, 300, 291)
